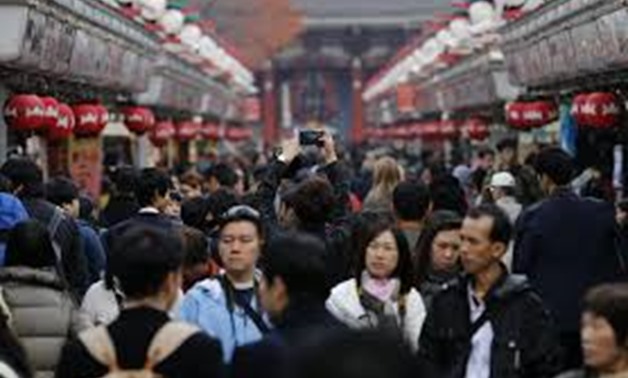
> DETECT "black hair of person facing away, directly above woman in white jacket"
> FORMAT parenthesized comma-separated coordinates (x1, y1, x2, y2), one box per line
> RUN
(393, 182, 432, 221)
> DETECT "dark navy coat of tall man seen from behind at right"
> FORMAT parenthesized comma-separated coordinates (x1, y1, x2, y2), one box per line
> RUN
(513, 190, 622, 332)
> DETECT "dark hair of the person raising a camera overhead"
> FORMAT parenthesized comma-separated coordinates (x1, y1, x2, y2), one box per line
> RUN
(282, 176, 336, 227)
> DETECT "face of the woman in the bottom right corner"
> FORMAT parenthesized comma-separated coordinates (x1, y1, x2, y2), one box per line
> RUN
(580, 312, 628, 373)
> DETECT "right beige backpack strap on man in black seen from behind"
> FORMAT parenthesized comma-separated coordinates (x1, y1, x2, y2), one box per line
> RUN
(144, 321, 200, 371)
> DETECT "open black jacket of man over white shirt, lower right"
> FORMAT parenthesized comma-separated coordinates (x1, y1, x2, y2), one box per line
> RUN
(419, 274, 561, 378)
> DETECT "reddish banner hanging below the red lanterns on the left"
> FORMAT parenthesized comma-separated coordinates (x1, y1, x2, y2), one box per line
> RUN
(70, 138, 103, 198)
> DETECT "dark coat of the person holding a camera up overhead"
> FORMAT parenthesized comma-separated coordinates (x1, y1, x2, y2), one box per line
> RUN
(257, 160, 351, 288)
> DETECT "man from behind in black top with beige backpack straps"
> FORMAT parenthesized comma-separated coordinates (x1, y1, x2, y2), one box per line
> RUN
(56, 226, 224, 378)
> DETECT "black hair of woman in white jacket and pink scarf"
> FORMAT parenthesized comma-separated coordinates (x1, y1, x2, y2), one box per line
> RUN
(354, 224, 414, 294)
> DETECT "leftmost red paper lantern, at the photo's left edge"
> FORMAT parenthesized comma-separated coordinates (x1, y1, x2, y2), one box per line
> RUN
(4, 95, 45, 131)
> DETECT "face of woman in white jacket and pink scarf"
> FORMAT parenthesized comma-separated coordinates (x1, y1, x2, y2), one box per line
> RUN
(366, 231, 399, 279)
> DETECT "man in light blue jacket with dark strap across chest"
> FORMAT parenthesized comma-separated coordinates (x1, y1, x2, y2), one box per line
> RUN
(181, 206, 268, 363)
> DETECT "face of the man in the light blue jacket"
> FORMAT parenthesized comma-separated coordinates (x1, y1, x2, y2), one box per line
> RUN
(218, 221, 262, 273)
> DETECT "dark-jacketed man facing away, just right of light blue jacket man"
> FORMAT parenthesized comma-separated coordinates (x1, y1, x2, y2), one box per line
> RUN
(232, 232, 343, 378)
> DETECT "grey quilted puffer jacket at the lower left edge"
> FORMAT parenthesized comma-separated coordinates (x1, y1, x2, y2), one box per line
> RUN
(0, 267, 83, 378)
